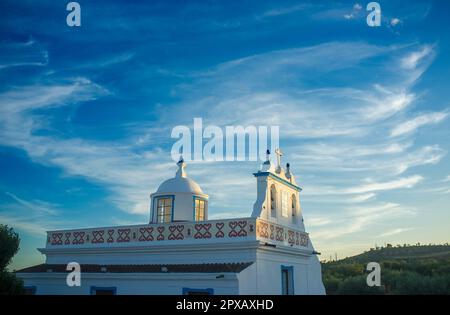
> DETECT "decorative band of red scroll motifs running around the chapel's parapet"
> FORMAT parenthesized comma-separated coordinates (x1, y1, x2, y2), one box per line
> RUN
(47, 218, 316, 247)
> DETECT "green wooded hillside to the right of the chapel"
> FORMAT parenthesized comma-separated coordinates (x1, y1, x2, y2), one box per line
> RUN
(322, 244, 450, 295)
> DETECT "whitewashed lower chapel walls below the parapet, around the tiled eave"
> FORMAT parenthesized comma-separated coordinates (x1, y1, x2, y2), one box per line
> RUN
(19, 247, 325, 295)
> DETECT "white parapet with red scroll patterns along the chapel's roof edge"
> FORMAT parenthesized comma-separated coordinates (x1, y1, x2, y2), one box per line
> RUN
(46, 218, 310, 250)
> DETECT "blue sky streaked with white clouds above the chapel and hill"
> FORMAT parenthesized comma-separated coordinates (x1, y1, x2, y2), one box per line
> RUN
(0, 0, 450, 267)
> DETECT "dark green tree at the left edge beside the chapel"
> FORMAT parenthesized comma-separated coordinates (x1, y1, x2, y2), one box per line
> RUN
(0, 224, 24, 295)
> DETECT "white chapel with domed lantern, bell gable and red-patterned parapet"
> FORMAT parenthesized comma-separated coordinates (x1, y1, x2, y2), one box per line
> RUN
(17, 150, 325, 295)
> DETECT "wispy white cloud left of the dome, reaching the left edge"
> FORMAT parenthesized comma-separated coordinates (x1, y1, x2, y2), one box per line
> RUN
(0, 78, 168, 214)
